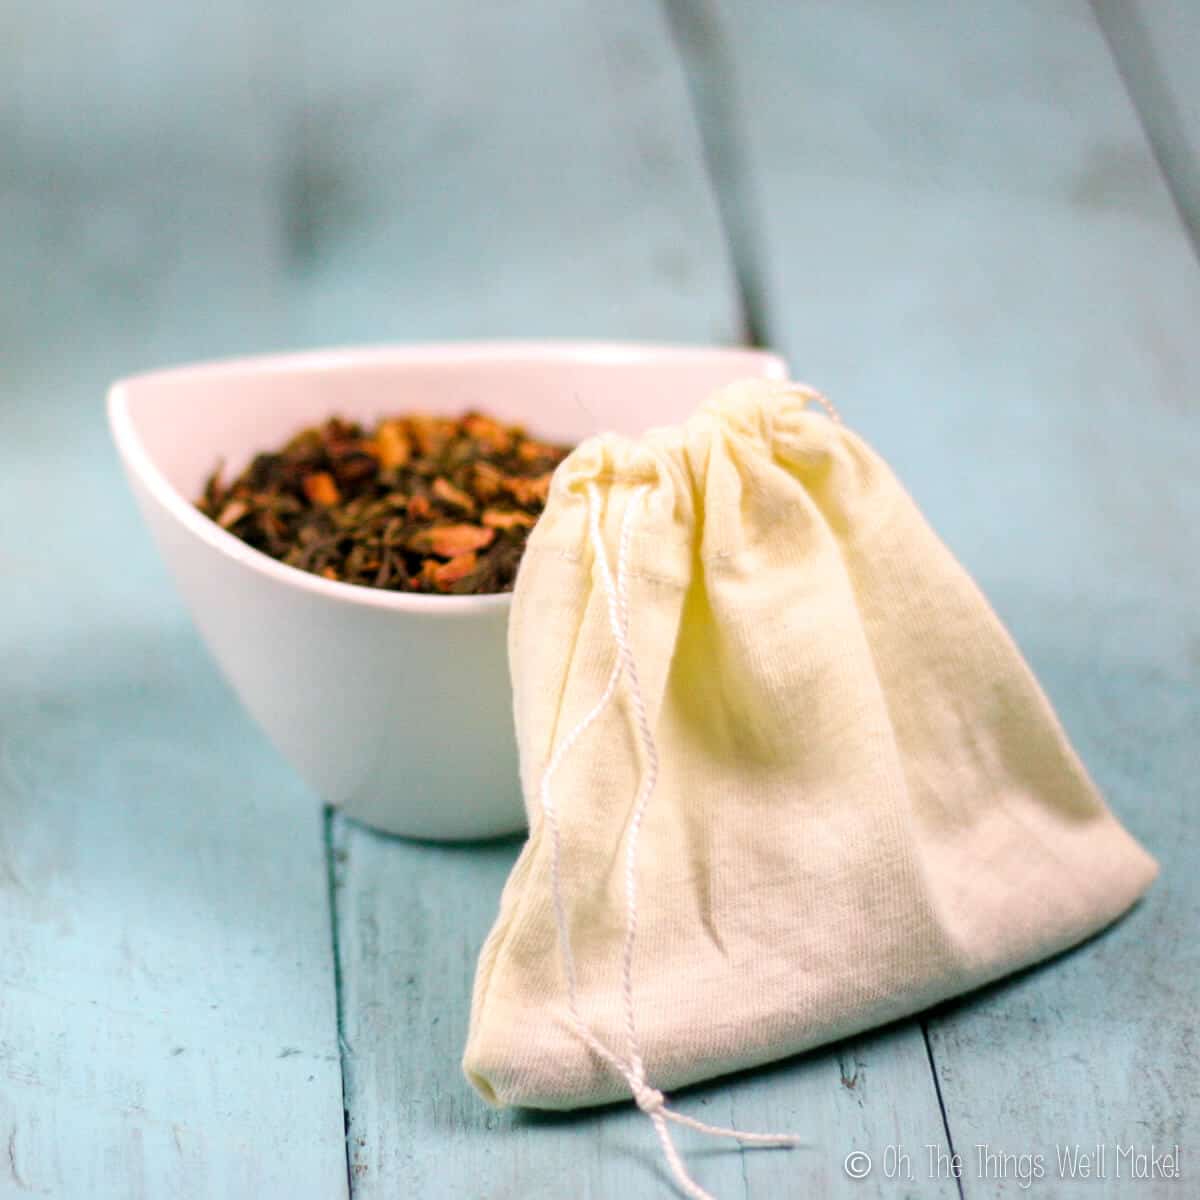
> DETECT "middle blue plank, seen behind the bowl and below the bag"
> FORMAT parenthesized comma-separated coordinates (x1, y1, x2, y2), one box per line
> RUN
(321, 2, 954, 1200)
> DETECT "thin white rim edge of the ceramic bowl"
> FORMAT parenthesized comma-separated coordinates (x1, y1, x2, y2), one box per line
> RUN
(107, 338, 787, 618)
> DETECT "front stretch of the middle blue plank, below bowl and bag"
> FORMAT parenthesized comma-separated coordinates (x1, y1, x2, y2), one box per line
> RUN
(336, 820, 955, 1200)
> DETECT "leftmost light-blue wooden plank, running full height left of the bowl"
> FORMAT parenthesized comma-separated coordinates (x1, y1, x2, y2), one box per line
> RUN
(0, 0, 347, 1200)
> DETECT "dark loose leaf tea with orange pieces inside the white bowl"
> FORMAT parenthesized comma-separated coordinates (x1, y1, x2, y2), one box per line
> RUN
(197, 413, 570, 594)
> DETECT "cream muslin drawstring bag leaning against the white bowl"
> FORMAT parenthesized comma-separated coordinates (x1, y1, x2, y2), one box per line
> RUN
(463, 380, 1157, 1196)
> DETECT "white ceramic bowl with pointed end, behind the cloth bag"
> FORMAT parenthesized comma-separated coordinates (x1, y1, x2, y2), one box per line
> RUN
(108, 342, 786, 839)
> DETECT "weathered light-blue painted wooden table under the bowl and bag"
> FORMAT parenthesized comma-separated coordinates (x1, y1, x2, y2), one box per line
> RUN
(0, 0, 1200, 1200)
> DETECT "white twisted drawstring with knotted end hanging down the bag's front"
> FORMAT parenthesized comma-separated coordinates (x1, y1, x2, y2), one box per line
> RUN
(540, 480, 801, 1200)
